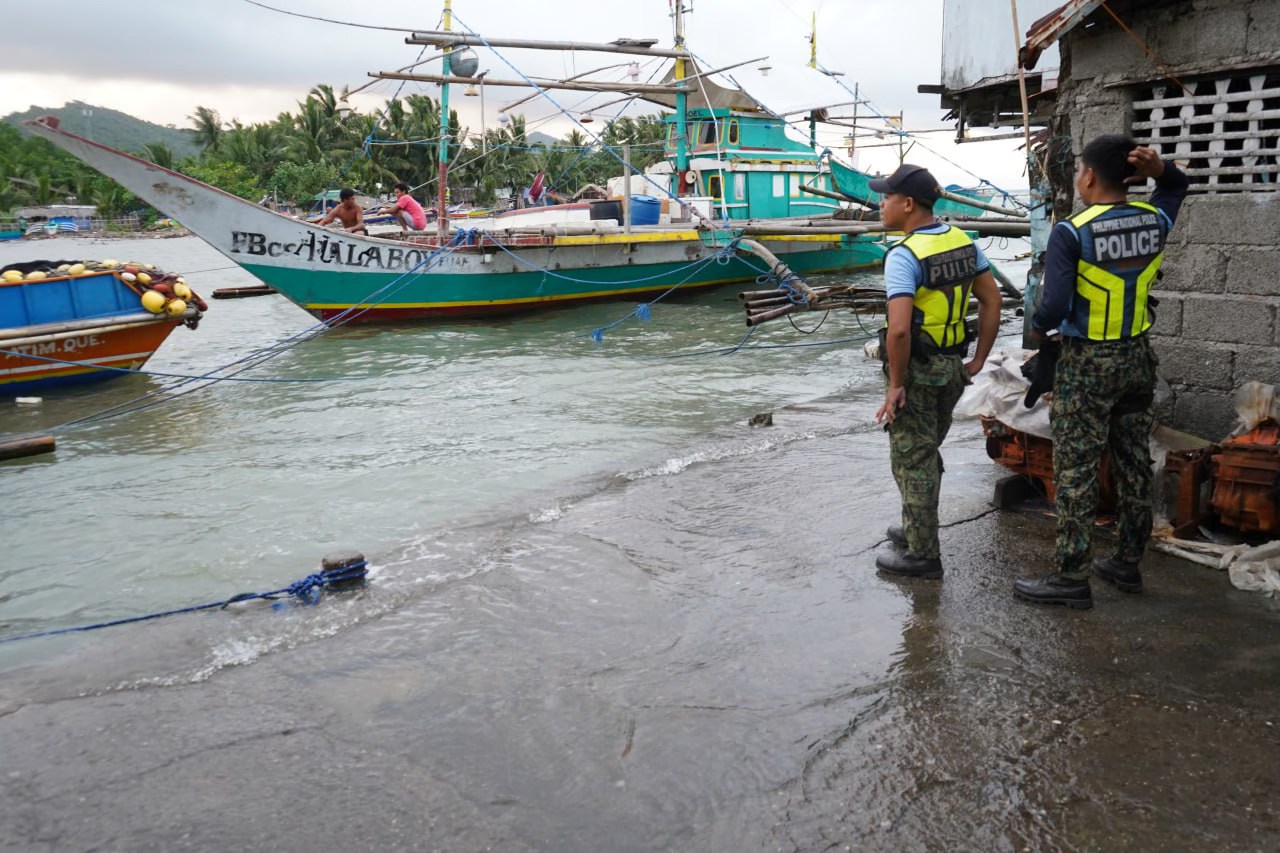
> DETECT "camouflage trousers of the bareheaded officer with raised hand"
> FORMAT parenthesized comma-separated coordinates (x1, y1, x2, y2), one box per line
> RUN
(1050, 336, 1157, 579)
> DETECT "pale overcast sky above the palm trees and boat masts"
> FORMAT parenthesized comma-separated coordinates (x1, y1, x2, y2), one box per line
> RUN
(0, 0, 1027, 191)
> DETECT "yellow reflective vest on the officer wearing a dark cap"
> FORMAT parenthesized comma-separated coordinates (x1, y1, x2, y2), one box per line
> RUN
(893, 227, 978, 350)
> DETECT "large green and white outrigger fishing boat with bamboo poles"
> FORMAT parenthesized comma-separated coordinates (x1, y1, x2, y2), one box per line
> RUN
(26, 0, 1013, 321)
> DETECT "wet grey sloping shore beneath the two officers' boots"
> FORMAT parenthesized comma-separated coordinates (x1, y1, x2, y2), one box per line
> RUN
(0, 412, 1280, 850)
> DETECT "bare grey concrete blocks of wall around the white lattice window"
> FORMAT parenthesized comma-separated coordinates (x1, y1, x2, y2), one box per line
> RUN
(1056, 0, 1280, 441)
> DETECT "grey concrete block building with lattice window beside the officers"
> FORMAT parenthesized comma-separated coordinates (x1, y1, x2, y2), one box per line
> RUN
(922, 0, 1280, 439)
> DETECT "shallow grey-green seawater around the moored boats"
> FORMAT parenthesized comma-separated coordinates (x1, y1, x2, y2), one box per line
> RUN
(0, 238, 1018, 692)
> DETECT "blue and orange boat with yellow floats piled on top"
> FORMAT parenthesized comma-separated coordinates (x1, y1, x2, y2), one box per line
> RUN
(0, 260, 207, 397)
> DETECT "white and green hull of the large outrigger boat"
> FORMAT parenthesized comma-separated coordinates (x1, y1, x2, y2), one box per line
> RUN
(27, 116, 883, 323)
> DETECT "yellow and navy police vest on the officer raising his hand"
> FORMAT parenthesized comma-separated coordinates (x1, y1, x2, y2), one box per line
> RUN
(1070, 201, 1169, 341)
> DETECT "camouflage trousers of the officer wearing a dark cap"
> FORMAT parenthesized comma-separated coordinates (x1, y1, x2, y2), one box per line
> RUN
(888, 355, 968, 557)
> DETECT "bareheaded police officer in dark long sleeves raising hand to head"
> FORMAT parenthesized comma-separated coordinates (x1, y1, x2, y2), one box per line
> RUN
(1014, 134, 1189, 610)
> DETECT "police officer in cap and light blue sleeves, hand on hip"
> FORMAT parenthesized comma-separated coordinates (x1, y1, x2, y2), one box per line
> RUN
(870, 164, 1000, 578)
